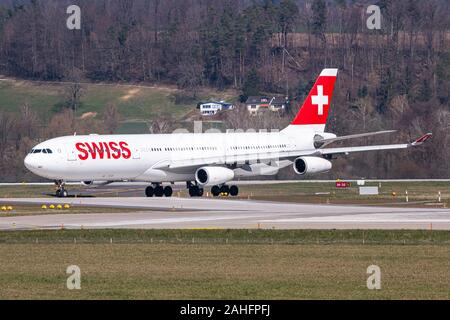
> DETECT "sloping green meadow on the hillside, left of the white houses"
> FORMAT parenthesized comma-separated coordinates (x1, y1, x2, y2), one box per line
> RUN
(0, 79, 237, 125)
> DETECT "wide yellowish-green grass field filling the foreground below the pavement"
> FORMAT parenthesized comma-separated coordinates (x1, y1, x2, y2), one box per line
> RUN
(0, 230, 450, 299)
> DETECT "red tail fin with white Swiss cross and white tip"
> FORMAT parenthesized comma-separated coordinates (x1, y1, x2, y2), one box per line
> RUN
(291, 69, 338, 126)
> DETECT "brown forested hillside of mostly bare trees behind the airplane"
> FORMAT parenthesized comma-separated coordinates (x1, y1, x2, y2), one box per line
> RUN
(0, 0, 450, 180)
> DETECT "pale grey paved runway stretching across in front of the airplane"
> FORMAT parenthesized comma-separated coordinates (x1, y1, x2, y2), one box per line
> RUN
(0, 197, 450, 230)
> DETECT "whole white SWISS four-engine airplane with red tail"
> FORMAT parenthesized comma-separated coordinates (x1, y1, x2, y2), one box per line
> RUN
(24, 69, 431, 197)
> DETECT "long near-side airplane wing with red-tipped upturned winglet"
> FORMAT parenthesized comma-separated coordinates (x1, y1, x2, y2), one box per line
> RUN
(152, 133, 432, 170)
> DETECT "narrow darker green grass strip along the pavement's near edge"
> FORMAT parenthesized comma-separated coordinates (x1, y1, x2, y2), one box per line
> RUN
(0, 229, 450, 245)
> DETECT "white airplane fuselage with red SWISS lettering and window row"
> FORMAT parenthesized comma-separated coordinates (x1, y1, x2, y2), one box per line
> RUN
(25, 130, 323, 182)
